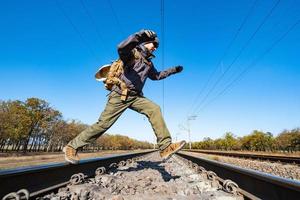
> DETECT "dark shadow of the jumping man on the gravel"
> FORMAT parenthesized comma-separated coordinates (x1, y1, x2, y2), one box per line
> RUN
(118, 161, 180, 182)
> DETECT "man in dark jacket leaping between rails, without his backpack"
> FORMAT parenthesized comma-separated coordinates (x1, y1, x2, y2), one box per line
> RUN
(63, 30, 186, 164)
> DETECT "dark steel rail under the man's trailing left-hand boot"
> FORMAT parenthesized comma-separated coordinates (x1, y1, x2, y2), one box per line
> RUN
(0, 150, 154, 199)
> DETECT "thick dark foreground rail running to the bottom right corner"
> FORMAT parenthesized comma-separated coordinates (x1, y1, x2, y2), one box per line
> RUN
(177, 152, 300, 200)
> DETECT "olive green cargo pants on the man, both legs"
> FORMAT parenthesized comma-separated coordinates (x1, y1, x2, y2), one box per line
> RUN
(68, 92, 171, 150)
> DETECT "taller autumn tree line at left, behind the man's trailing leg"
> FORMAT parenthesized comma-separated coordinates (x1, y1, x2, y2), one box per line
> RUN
(0, 98, 152, 152)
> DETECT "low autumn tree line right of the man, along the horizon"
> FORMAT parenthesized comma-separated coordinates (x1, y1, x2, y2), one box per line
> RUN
(192, 128, 300, 152)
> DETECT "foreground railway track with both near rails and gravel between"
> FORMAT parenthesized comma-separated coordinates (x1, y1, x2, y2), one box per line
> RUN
(0, 151, 300, 200)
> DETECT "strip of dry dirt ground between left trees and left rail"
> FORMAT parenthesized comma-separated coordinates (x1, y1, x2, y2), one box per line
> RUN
(0, 150, 141, 170)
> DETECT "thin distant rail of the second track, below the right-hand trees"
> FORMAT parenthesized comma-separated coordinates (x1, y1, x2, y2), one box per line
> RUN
(185, 150, 300, 164)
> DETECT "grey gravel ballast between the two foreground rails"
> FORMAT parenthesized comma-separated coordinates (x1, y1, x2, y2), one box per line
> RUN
(40, 153, 243, 200)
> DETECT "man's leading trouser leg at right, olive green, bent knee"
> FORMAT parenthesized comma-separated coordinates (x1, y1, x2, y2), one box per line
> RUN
(129, 97, 172, 150)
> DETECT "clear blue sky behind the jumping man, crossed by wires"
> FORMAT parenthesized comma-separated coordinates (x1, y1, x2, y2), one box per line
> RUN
(0, 0, 300, 142)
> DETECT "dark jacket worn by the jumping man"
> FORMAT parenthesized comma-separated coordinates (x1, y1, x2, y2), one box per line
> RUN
(113, 33, 176, 95)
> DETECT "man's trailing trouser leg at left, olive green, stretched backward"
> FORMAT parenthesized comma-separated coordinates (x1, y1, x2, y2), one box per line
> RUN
(68, 92, 129, 149)
